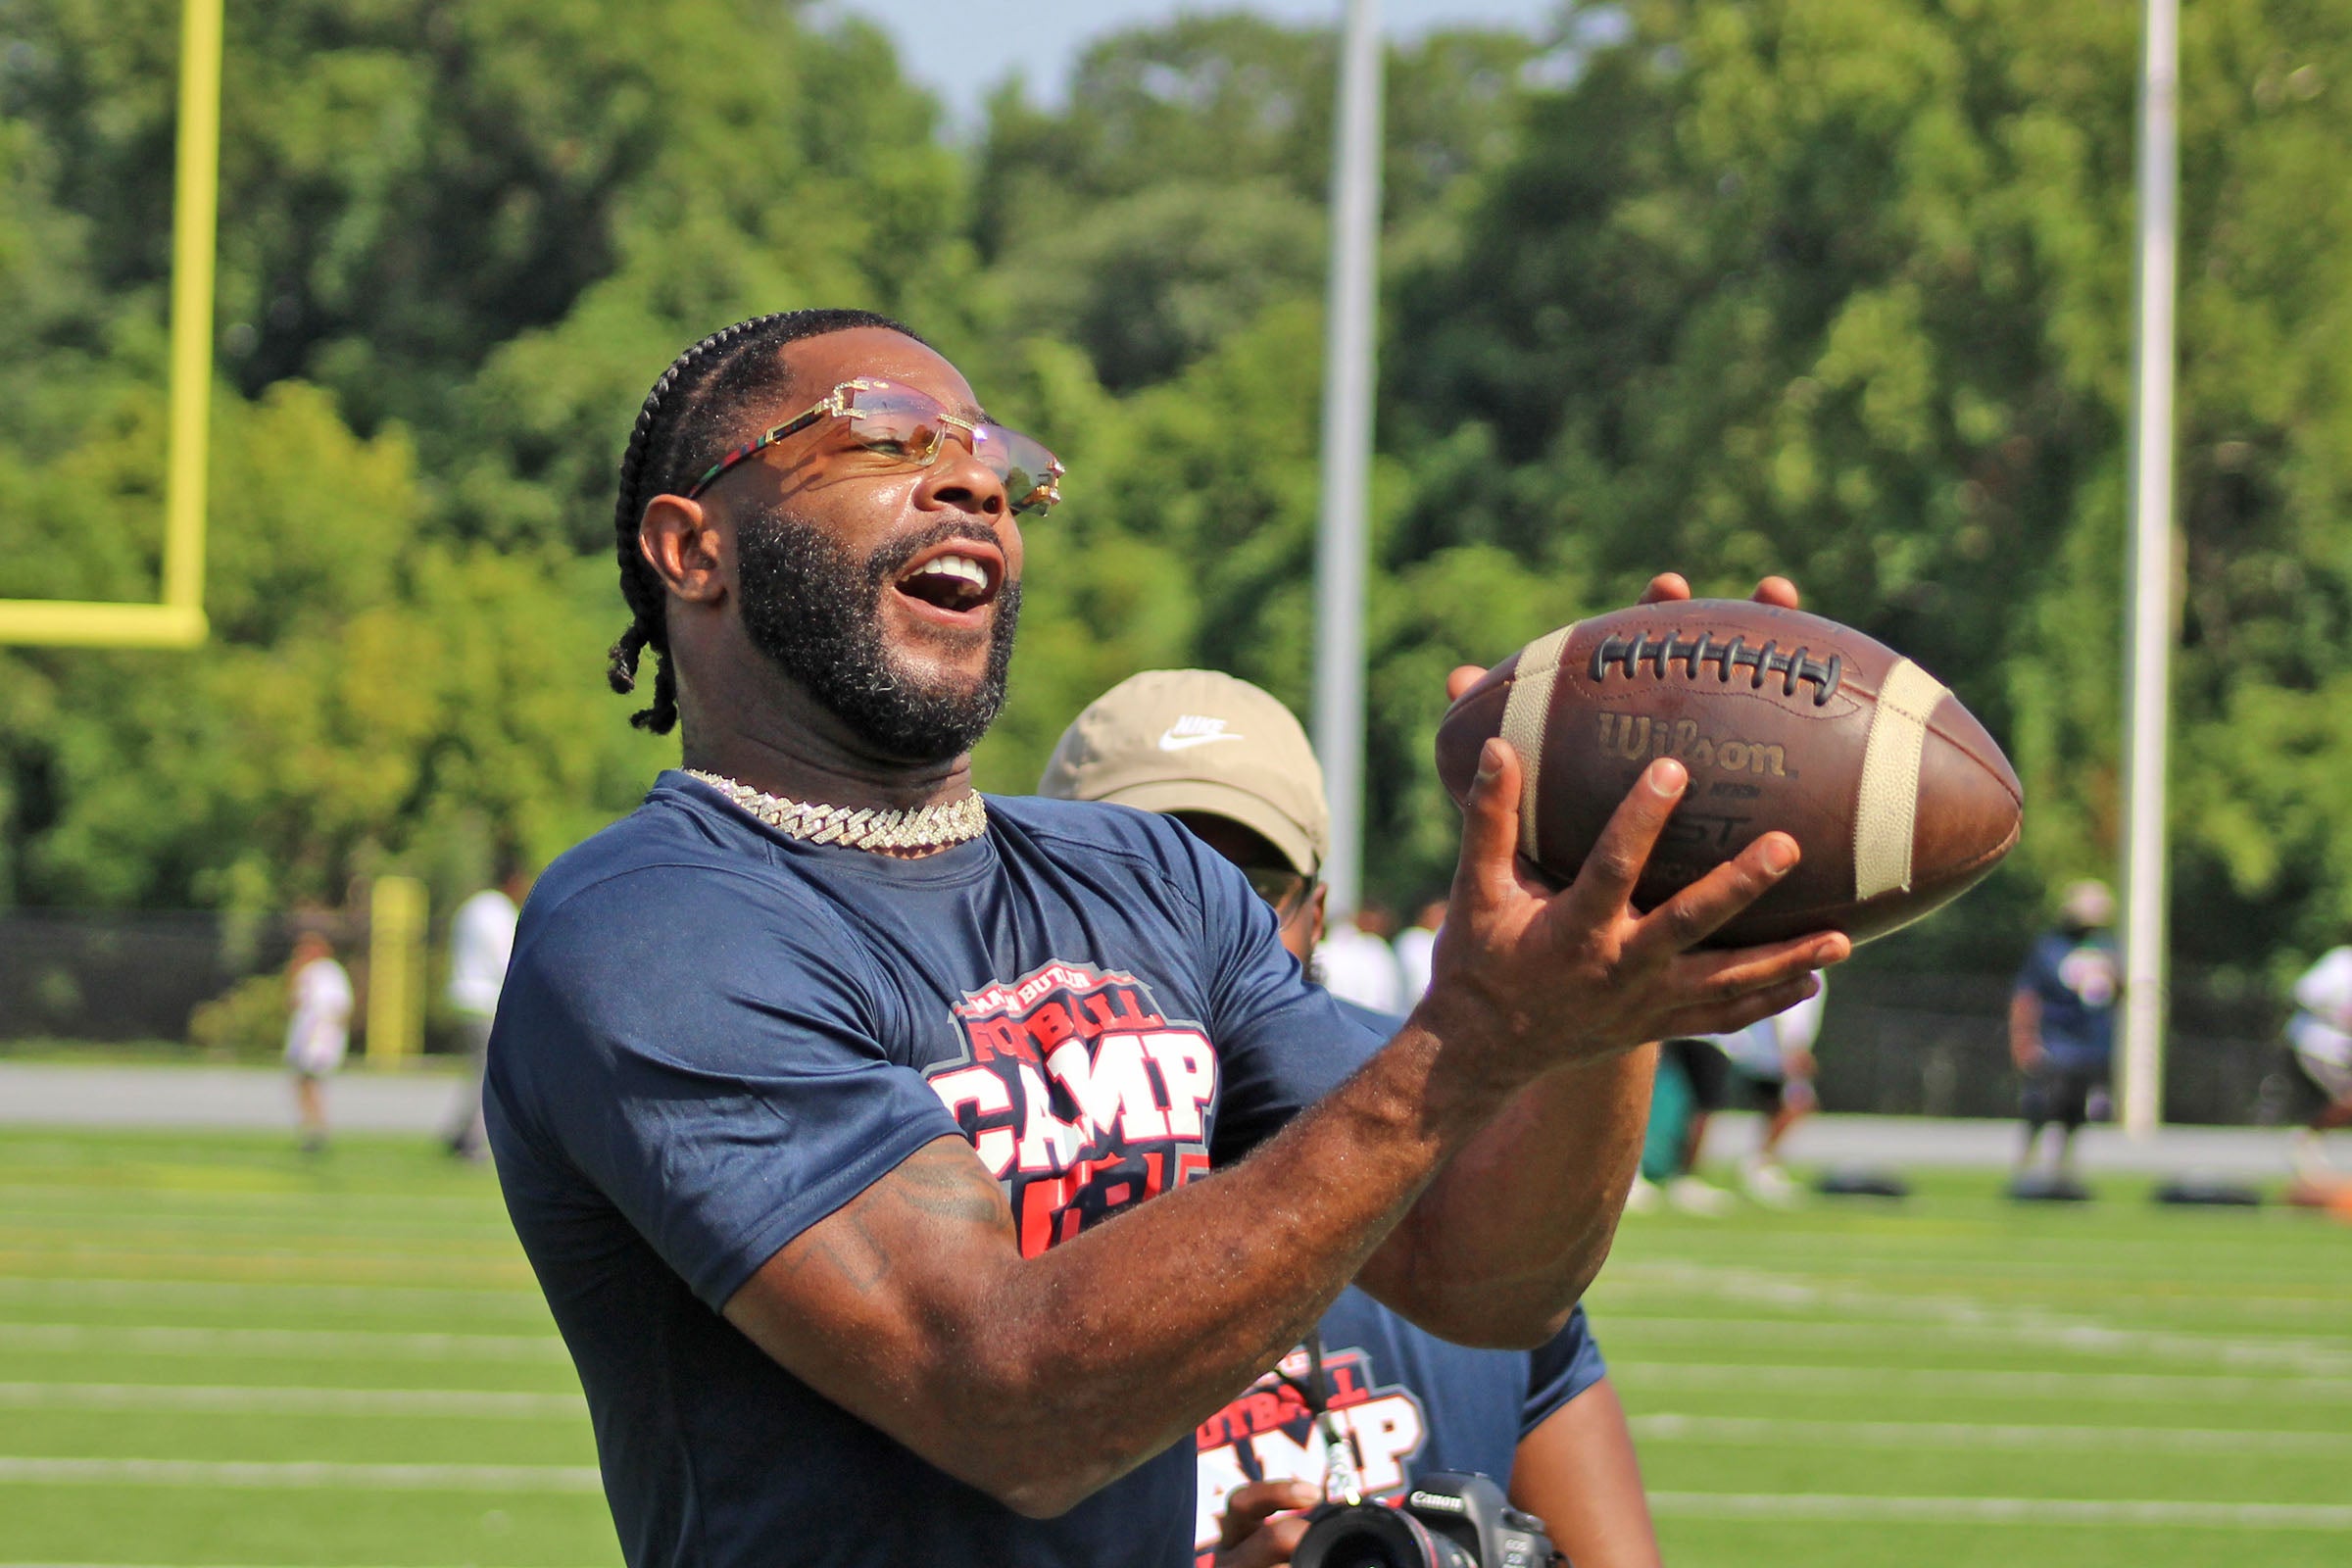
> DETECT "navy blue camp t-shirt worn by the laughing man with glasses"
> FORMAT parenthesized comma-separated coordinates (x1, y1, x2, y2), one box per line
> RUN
(487, 773, 1378, 1568)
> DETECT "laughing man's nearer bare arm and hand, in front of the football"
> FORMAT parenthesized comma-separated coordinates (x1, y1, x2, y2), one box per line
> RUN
(727, 741, 1841, 1516)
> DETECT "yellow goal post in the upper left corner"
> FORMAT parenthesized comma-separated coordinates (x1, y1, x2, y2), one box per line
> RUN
(0, 0, 223, 649)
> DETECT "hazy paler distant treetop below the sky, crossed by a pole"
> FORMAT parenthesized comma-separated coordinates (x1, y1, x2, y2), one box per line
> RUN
(971, 12, 1539, 393)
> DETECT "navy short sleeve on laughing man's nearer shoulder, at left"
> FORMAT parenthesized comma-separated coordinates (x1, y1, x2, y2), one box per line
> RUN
(489, 867, 957, 1309)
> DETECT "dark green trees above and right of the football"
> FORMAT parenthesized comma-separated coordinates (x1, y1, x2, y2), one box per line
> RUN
(1388, 0, 2352, 961)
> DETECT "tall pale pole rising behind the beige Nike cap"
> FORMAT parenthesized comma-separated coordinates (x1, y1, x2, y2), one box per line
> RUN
(1315, 0, 1383, 914)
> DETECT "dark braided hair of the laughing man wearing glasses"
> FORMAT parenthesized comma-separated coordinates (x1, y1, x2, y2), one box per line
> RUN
(605, 311, 922, 736)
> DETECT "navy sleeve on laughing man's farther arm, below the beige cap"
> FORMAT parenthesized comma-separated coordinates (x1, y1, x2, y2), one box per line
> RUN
(1183, 835, 1388, 1166)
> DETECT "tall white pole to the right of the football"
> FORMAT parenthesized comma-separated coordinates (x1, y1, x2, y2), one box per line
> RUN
(2124, 0, 2180, 1138)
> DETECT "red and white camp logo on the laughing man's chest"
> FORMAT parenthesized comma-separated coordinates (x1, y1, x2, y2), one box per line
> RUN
(924, 964, 1216, 1257)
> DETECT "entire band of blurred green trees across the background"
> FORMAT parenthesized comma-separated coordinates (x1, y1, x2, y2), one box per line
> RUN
(0, 0, 2352, 987)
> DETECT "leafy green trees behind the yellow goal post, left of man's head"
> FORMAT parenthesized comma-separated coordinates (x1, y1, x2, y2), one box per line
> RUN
(0, 0, 971, 907)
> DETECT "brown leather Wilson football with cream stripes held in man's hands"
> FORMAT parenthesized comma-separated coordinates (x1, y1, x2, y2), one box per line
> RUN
(1437, 600, 2023, 948)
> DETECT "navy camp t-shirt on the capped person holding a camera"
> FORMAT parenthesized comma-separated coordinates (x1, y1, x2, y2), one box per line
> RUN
(1193, 1002, 1609, 1568)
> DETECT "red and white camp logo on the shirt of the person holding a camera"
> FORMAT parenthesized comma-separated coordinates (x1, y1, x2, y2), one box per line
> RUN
(1193, 1349, 1430, 1568)
